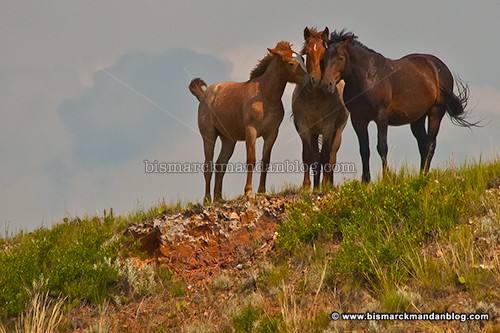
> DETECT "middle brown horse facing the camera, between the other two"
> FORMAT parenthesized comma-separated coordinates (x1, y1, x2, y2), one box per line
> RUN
(292, 27, 349, 190)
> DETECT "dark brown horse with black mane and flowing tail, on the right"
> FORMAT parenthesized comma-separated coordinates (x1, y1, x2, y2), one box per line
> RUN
(321, 30, 477, 183)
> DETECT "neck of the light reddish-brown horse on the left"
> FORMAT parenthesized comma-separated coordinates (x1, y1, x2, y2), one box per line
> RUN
(251, 59, 287, 103)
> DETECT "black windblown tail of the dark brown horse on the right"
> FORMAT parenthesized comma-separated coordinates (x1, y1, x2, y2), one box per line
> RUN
(441, 76, 479, 128)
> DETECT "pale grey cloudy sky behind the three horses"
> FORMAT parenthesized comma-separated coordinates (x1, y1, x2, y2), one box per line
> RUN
(0, 0, 500, 234)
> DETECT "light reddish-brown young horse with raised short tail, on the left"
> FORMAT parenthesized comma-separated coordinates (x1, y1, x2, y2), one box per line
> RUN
(189, 42, 308, 201)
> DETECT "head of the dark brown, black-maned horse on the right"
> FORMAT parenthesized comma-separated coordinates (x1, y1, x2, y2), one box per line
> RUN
(321, 35, 356, 93)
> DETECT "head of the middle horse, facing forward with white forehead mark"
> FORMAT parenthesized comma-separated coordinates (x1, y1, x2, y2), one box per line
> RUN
(301, 27, 330, 86)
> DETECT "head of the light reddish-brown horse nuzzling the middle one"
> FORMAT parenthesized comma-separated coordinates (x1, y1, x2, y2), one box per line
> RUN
(268, 42, 309, 84)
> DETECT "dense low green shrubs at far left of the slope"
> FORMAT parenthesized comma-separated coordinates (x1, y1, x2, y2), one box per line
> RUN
(0, 218, 124, 317)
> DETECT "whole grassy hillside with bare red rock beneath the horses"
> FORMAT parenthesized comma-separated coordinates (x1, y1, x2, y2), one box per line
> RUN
(0, 160, 500, 332)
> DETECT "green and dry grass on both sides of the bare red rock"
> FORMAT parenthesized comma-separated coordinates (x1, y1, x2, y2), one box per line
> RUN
(0, 161, 500, 332)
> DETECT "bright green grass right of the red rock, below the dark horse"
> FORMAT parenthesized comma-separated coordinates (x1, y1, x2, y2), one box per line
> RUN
(278, 163, 500, 294)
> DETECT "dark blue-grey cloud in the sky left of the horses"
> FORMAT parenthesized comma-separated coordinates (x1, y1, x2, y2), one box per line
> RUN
(59, 50, 229, 168)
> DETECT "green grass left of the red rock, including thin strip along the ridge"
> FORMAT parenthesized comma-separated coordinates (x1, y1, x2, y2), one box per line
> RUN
(0, 205, 181, 318)
